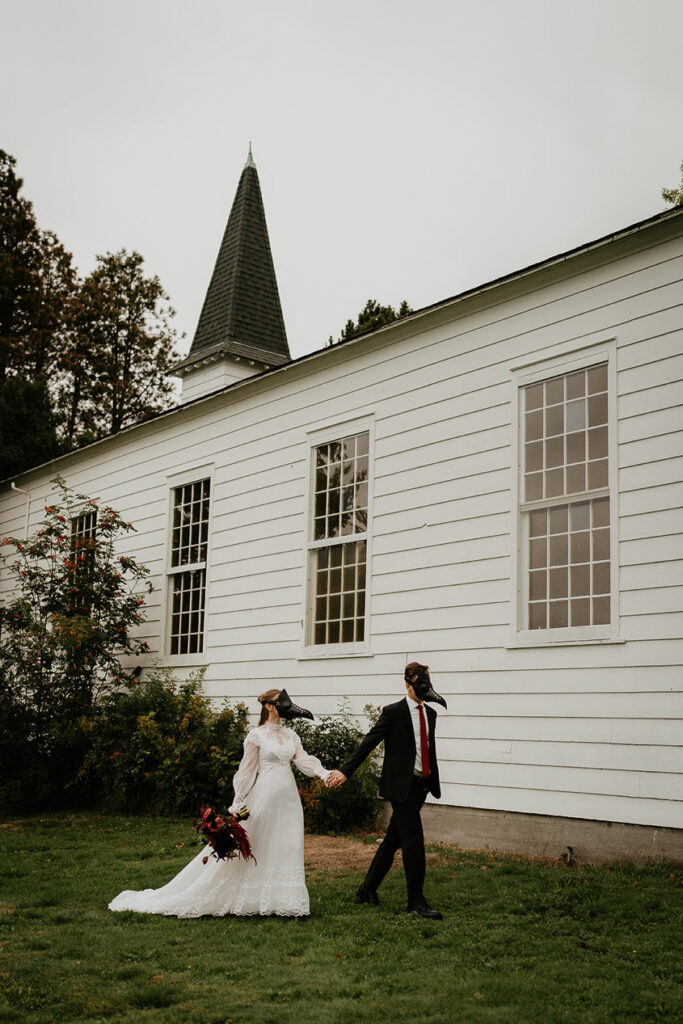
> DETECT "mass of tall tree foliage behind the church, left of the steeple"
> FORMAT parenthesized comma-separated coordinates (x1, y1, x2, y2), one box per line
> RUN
(0, 150, 179, 478)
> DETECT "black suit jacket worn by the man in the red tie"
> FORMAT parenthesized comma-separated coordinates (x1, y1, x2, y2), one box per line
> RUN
(340, 699, 441, 802)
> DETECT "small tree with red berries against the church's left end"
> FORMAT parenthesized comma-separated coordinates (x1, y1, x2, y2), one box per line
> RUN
(0, 477, 152, 802)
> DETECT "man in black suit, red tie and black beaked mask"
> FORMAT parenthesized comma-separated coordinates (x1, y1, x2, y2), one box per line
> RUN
(328, 662, 446, 921)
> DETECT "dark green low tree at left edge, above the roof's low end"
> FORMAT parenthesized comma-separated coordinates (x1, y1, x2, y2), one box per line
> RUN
(0, 375, 59, 480)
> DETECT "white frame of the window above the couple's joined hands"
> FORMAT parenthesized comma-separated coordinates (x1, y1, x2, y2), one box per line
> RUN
(299, 414, 375, 660)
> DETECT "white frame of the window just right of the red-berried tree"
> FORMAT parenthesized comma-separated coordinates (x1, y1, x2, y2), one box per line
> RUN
(159, 463, 215, 668)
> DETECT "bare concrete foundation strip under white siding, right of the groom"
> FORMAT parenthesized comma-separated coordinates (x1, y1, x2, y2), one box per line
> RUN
(422, 804, 683, 867)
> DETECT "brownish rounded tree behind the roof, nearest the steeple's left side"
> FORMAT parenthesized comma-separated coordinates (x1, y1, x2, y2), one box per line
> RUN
(59, 249, 180, 443)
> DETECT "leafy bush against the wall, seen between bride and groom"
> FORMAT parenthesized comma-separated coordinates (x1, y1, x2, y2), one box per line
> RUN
(293, 700, 382, 834)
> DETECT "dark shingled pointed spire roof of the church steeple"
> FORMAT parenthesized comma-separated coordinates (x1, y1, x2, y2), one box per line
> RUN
(176, 144, 291, 370)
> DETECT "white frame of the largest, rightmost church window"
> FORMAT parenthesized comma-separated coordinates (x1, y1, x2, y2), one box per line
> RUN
(508, 338, 622, 647)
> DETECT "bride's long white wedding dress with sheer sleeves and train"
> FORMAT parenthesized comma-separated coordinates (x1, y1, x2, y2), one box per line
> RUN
(109, 723, 330, 918)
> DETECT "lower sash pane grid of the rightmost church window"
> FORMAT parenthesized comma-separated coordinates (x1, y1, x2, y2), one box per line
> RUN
(528, 498, 610, 630)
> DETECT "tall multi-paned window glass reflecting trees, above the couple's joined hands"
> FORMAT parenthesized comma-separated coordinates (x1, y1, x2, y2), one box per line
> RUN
(308, 431, 370, 645)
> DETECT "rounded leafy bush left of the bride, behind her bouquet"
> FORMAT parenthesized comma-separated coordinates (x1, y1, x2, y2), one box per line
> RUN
(78, 669, 247, 814)
